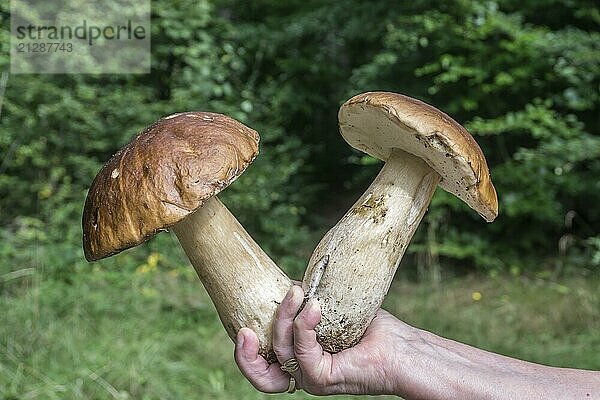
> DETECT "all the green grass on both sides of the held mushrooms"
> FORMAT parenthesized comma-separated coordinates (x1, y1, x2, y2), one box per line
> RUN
(0, 258, 600, 400)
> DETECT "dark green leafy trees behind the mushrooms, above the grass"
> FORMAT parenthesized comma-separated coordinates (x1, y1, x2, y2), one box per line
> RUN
(0, 0, 600, 277)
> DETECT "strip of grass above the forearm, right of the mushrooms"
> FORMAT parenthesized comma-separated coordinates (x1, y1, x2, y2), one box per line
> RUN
(384, 276, 600, 370)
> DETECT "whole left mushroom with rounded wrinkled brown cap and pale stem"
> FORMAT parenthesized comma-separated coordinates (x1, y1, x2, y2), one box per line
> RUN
(83, 112, 292, 361)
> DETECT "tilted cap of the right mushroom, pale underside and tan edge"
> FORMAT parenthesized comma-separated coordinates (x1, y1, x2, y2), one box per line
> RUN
(338, 92, 498, 222)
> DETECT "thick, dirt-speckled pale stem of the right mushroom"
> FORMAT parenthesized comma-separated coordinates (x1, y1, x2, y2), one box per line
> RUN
(302, 150, 440, 352)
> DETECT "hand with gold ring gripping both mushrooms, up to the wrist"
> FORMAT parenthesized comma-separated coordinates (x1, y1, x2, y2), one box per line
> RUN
(235, 286, 413, 395)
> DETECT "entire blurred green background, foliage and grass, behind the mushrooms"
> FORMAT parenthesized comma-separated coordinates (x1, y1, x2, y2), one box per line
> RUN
(0, 0, 600, 400)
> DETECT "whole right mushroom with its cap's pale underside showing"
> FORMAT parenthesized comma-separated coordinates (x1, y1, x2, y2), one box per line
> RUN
(302, 92, 498, 352)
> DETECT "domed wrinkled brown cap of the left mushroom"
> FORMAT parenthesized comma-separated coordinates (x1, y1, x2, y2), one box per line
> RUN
(82, 112, 259, 261)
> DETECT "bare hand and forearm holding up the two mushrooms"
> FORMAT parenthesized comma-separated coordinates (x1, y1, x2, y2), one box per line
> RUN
(235, 286, 600, 400)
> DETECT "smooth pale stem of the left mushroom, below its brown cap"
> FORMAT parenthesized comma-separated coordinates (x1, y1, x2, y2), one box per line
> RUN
(172, 196, 292, 361)
